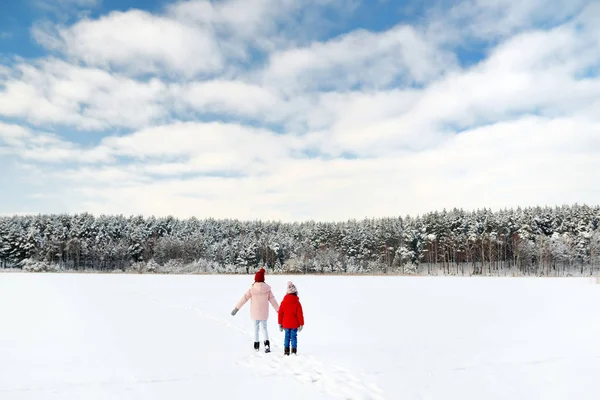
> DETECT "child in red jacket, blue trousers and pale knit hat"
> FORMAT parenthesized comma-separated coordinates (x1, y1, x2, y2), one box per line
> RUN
(279, 282, 304, 356)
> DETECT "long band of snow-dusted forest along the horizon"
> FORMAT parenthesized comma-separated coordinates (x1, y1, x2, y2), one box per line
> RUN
(0, 205, 600, 276)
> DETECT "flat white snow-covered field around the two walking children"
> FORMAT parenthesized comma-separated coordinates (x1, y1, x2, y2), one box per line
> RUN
(0, 273, 600, 400)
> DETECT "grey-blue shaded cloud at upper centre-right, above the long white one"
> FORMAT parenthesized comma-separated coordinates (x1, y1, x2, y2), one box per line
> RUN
(262, 25, 456, 91)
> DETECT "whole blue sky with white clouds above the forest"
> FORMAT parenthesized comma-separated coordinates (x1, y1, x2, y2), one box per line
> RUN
(0, 0, 600, 221)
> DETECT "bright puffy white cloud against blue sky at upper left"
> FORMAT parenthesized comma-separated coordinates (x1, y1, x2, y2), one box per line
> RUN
(32, 0, 356, 79)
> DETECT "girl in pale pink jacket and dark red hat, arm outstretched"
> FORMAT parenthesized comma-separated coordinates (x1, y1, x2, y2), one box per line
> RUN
(231, 268, 279, 353)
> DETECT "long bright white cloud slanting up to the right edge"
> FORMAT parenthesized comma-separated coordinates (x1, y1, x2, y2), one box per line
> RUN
(292, 19, 600, 156)
